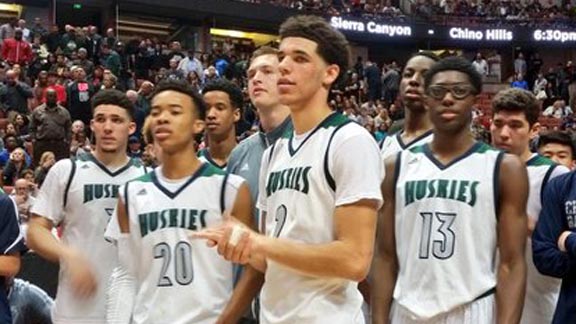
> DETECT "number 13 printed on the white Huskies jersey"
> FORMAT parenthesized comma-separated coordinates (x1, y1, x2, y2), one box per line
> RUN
(418, 212, 456, 260)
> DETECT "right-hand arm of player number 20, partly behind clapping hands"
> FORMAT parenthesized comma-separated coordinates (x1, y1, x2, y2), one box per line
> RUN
(217, 183, 264, 324)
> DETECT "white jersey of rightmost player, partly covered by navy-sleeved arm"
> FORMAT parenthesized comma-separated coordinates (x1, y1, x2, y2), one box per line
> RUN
(521, 154, 568, 324)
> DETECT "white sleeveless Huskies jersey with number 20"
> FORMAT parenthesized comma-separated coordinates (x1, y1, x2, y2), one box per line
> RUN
(120, 163, 243, 324)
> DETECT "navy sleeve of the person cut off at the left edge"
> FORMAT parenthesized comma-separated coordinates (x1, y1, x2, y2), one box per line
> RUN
(0, 195, 26, 255)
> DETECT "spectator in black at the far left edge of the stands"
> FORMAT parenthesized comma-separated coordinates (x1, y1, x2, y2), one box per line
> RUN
(0, 70, 34, 119)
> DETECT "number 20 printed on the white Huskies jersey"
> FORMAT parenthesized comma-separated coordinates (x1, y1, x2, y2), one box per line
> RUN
(154, 241, 194, 287)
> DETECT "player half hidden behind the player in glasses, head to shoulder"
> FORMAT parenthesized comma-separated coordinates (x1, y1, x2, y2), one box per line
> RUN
(380, 52, 438, 160)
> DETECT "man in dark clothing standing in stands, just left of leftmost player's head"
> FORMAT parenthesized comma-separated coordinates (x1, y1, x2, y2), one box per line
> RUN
(30, 90, 72, 165)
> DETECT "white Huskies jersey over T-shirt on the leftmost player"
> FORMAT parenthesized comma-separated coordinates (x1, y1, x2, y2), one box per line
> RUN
(32, 153, 146, 324)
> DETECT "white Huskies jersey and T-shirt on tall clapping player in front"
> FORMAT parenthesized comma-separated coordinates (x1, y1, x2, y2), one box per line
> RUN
(258, 113, 383, 324)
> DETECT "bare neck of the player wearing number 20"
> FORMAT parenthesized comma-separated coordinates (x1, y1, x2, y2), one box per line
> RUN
(162, 143, 202, 180)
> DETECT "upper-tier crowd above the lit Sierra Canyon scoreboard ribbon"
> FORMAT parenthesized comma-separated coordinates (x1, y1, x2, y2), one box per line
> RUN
(235, 0, 576, 26)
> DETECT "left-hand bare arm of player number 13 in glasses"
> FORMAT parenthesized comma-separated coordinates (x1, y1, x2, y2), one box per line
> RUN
(370, 158, 398, 324)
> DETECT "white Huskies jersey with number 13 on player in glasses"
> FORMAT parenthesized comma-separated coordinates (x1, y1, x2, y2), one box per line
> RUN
(394, 142, 504, 320)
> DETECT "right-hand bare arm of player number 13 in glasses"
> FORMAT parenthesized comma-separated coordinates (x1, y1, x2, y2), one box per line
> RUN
(496, 154, 528, 323)
